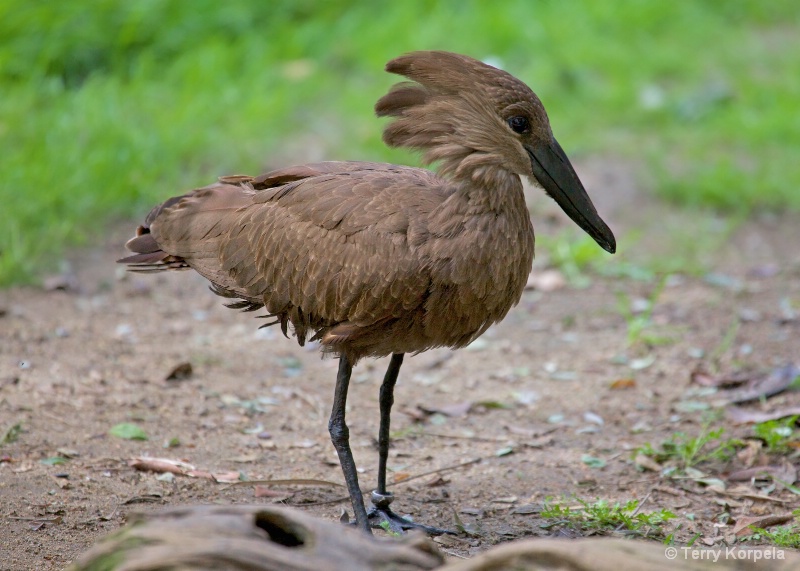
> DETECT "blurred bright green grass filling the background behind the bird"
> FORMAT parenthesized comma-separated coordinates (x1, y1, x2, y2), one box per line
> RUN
(0, 0, 800, 284)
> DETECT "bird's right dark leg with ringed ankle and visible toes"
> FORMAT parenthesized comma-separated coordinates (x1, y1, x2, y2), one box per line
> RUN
(369, 353, 453, 535)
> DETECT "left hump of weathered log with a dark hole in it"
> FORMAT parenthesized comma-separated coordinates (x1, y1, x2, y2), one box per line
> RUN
(70, 506, 444, 571)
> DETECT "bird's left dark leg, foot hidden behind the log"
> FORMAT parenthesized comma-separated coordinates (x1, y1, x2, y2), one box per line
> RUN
(328, 355, 372, 534)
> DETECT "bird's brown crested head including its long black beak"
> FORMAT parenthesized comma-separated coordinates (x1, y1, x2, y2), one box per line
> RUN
(375, 51, 616, 253)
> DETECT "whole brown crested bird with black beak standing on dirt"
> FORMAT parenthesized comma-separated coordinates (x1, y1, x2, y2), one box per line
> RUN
(120, 51, 616, 533)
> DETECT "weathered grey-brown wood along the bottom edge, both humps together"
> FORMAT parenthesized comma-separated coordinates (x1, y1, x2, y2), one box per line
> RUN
(69, 506, 800, 571)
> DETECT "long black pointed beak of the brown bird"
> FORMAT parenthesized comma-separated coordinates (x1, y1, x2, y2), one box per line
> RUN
(525, 139, 617, 254)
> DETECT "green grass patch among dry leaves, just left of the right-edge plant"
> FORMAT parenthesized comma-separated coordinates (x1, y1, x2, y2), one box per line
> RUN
(633, 426, 743, 470)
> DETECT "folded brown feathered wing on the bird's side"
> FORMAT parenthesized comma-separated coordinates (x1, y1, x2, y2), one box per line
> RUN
(151, 163, 445, 336)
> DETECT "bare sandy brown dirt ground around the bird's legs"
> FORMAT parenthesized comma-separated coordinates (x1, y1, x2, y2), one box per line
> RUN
(0, 161, 800, 570)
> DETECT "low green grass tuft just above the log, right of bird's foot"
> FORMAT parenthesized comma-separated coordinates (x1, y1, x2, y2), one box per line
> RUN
(541, 497, 676, 537)
